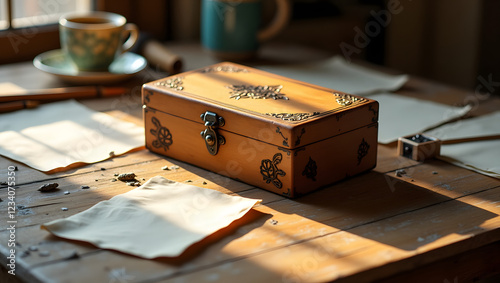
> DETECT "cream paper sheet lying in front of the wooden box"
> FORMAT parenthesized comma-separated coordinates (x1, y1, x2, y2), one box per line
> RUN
(42, 176, 261, 259)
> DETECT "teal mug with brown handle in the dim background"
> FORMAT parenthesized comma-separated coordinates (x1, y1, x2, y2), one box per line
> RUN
(201, 0, 291, 60)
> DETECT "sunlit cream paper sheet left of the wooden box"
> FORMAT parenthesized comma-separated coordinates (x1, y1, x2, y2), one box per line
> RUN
(0, 100, 144, 172)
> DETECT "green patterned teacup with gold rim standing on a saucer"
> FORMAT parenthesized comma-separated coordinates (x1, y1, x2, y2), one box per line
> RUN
(59, 12, 139, 71)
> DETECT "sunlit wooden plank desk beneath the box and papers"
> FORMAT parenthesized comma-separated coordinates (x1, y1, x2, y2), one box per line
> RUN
(0, 43, 500, 282)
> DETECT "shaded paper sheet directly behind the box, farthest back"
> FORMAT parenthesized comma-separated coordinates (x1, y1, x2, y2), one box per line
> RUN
(260, 56, 408, 95)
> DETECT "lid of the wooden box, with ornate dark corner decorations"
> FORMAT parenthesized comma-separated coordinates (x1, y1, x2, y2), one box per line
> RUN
(142, 62, 379, 149)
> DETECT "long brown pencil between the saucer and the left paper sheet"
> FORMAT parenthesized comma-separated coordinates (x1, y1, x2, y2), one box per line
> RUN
(0, 86, 127, 102)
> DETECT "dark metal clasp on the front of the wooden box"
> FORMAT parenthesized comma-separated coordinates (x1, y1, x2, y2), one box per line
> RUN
(200, 111, 226, 155)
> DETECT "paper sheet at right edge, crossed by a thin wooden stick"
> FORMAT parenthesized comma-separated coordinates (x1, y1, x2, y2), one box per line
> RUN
(425, 111, 500, 178)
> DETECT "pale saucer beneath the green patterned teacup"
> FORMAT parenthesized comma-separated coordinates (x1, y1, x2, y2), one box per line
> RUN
(33, 49, 147, 84)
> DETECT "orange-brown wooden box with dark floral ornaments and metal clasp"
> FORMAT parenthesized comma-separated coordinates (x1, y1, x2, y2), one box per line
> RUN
(142, 63, 379, 197)
